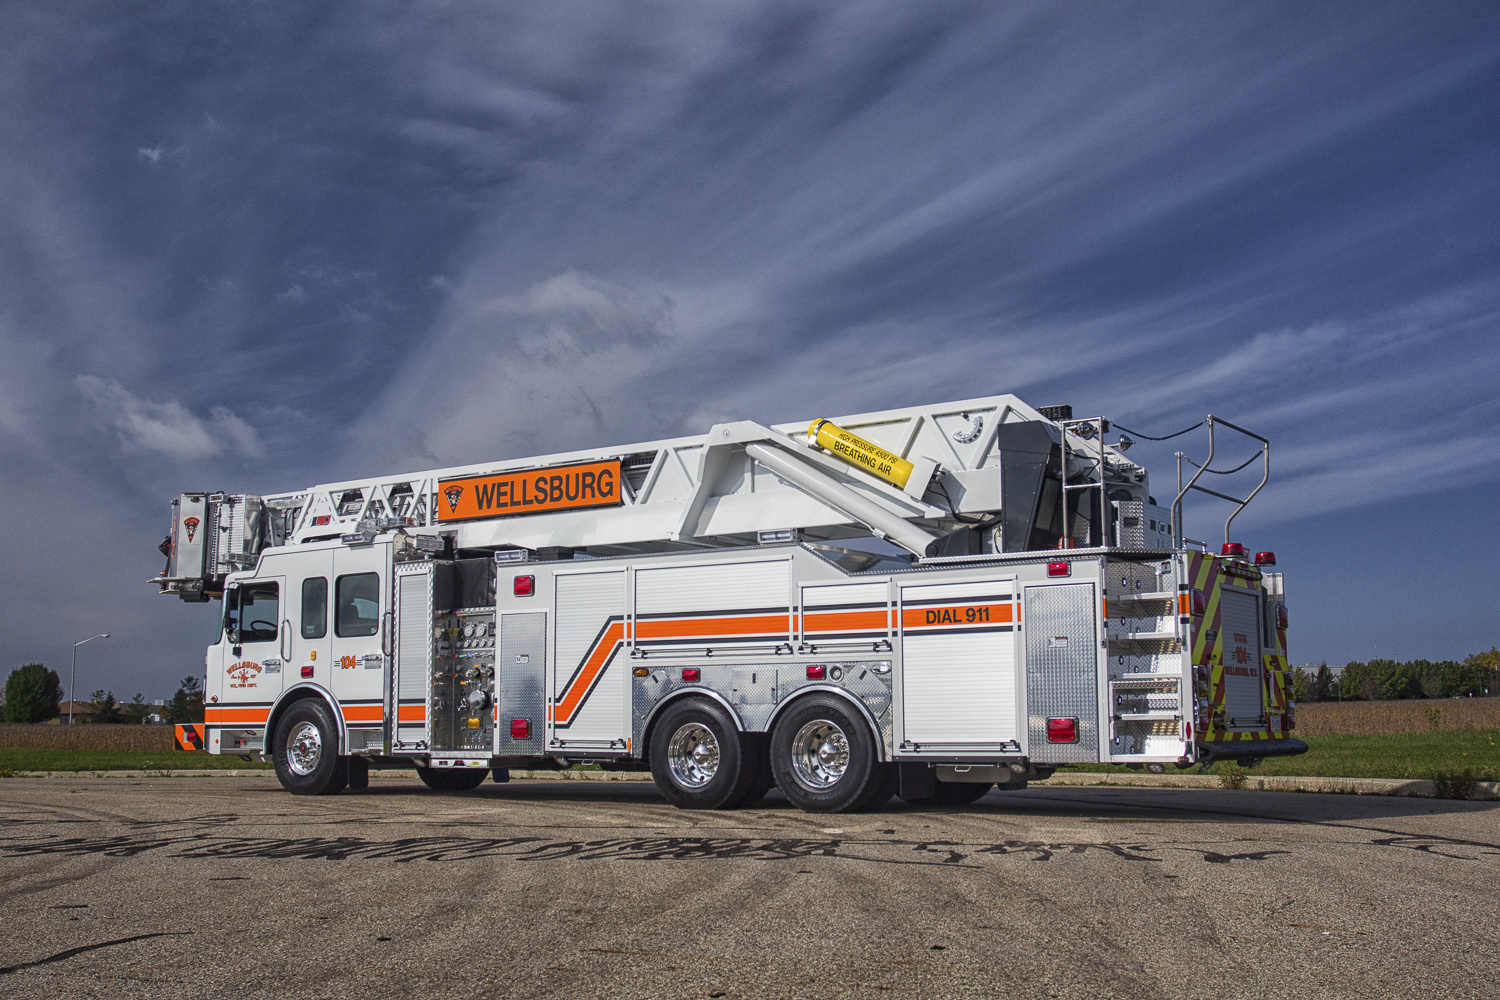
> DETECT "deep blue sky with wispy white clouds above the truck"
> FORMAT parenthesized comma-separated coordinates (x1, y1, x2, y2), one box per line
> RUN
(0, 0, 1500, 699)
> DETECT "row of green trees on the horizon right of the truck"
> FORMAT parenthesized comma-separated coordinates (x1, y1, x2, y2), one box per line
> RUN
(1292, 649, 1500, 702)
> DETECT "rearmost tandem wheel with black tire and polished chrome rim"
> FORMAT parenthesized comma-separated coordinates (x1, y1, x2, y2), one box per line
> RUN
(771, 694, 887, 813)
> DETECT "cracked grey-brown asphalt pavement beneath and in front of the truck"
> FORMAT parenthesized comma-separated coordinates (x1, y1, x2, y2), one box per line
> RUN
(0, 774, 1500, 1000)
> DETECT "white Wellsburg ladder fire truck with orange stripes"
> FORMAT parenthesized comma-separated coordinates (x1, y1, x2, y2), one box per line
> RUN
(155, 396, 1307, 813)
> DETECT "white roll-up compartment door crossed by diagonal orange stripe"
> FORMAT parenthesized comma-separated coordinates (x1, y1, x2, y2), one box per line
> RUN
(548, 570, 630, 751)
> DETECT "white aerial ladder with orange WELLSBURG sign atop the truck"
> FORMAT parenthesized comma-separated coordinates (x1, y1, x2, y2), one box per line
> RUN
(266, 396, 1124, 555)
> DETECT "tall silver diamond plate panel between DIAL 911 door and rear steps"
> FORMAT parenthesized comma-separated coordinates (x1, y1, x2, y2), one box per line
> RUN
(1022, 583, 1100, 763)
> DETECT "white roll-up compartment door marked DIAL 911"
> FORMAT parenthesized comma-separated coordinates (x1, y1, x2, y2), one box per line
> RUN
(899, 579, 1020, 753)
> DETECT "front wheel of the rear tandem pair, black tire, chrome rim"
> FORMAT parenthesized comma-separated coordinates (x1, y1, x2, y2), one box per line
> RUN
(651, 699, 759, 810)
